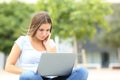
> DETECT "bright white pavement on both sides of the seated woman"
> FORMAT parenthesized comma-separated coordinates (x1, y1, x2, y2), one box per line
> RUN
(0, 69, 120, 80)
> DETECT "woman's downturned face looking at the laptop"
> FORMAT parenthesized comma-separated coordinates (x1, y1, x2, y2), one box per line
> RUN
(35, 23, 51, 40)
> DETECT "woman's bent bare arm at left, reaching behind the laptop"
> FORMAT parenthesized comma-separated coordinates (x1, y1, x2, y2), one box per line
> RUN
(5, 44, 25, 74)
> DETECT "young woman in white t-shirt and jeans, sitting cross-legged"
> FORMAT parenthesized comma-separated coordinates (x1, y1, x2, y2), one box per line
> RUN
(5, 11, 88, 80)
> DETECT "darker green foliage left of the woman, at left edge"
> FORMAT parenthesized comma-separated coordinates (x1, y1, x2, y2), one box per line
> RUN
(0, 2, 34, 54)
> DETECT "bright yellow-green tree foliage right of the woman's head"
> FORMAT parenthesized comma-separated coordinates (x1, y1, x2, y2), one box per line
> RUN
(36, 0, 112, 39)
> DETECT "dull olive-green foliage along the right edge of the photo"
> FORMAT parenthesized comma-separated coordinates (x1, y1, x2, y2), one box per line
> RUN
(100, 4, 120, 48)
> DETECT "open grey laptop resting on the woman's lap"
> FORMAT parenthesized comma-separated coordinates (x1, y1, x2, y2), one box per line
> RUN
(37, 53, 75, 76)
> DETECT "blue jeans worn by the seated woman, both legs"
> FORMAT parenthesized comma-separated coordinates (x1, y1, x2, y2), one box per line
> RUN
(19, 68, 88, 80)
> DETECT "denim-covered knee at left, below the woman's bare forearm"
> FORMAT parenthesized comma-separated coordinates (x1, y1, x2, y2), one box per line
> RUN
(19, 71, 42, 80)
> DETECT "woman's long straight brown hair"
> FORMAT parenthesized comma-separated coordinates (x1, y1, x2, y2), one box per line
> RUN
(28, 11, 52, 37)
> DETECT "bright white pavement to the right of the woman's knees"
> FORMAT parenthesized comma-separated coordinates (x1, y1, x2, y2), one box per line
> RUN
(88, 69, 120, 80)
